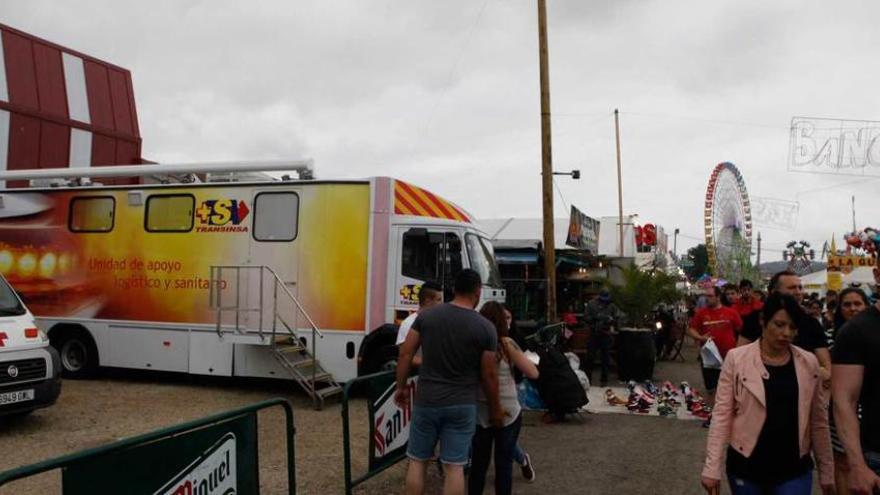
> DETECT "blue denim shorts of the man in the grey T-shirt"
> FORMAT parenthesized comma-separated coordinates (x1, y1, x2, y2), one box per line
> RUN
(406, 404, 477, 466)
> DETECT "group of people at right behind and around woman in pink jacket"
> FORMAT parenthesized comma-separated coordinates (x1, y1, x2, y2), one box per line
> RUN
(688, 270, 880, 495)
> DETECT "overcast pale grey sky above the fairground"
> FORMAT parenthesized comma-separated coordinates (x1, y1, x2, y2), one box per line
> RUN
(0, 0, 880, 261)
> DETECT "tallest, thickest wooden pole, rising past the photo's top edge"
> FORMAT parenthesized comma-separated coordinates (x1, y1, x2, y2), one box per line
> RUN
(538, 0, 556, 324)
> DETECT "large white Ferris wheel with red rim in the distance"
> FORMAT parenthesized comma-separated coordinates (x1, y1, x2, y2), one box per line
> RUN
(704, 162, 752, 276)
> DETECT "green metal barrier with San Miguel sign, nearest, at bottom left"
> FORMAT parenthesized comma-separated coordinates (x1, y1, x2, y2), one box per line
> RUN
(0, 398, 296, 495)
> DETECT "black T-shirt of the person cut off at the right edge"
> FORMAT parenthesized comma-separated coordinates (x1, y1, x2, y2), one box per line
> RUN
(832, 305, 880, 452)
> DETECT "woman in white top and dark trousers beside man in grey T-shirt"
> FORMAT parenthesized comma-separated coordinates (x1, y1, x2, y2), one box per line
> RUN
(468, 301, 538, 495)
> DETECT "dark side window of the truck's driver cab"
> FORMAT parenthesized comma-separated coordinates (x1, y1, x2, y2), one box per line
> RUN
(401, 232, 462, 287)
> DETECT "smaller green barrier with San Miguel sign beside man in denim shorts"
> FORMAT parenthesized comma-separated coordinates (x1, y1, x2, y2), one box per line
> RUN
(342, 371, 418, 495)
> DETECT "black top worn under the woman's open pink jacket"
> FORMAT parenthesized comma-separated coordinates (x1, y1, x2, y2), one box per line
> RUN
(727, 356, 813, 484)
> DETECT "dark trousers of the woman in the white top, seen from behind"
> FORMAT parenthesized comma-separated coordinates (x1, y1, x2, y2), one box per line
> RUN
(468, 414, 522, 495)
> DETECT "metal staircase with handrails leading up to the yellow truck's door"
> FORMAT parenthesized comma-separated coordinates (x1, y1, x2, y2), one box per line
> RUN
(210, 265, 342, 410)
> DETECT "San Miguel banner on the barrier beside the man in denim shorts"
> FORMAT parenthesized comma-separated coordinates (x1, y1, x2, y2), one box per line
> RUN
(368, 373, 419, 471)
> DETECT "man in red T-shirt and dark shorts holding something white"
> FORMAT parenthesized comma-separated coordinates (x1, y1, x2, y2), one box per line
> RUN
(688, 287, 742, 405)
